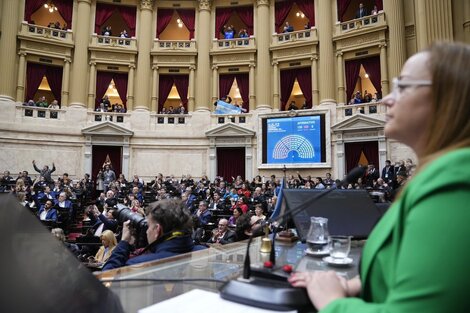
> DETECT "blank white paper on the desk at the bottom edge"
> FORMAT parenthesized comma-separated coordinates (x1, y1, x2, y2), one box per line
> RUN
(139, 289, 297, 313)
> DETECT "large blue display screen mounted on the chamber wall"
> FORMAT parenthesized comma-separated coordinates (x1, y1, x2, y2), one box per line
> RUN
(262, 114, 325, 164)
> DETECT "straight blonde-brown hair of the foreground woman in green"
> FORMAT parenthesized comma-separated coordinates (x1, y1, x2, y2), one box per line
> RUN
(420, 42, 470, 163)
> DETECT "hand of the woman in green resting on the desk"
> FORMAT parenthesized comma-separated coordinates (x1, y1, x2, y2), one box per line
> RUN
(289, 271, 356, 310)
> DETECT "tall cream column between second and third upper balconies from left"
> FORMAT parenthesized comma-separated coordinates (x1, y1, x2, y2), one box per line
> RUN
(134, 0, 153, 111)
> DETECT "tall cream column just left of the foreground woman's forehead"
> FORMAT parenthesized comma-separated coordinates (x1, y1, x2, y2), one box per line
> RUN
(380, 0, 406, 79)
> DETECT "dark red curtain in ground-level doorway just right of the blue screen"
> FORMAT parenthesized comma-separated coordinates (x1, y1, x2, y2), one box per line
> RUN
(344, 141, 379, 172)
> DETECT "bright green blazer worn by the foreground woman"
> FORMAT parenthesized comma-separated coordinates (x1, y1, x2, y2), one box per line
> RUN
(321, 148, 470, 313)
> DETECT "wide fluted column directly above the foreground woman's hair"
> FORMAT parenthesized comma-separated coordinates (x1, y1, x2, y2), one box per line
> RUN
(416, 0, 454, 51)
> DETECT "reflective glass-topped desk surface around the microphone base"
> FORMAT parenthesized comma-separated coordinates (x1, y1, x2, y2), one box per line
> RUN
(95, 238, 361, 313)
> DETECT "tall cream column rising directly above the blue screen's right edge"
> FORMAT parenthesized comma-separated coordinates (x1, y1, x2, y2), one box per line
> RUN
(316, 1, 336, 104)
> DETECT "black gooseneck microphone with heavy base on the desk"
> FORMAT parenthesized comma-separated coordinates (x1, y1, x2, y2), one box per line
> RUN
(220, 166, 366, 311)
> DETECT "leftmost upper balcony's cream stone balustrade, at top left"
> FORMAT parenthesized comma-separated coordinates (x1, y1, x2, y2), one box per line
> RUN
(18, 21, 74, 47)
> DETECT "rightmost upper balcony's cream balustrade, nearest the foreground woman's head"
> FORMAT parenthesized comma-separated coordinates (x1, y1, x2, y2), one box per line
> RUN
(334, 11, 387, 37)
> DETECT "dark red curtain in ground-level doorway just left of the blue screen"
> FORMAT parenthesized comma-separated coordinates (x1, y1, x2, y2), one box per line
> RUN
(217, 147, 245, 181)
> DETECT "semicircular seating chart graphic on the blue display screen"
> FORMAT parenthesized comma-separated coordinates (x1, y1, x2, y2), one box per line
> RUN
(273, 135, 315, 160)
